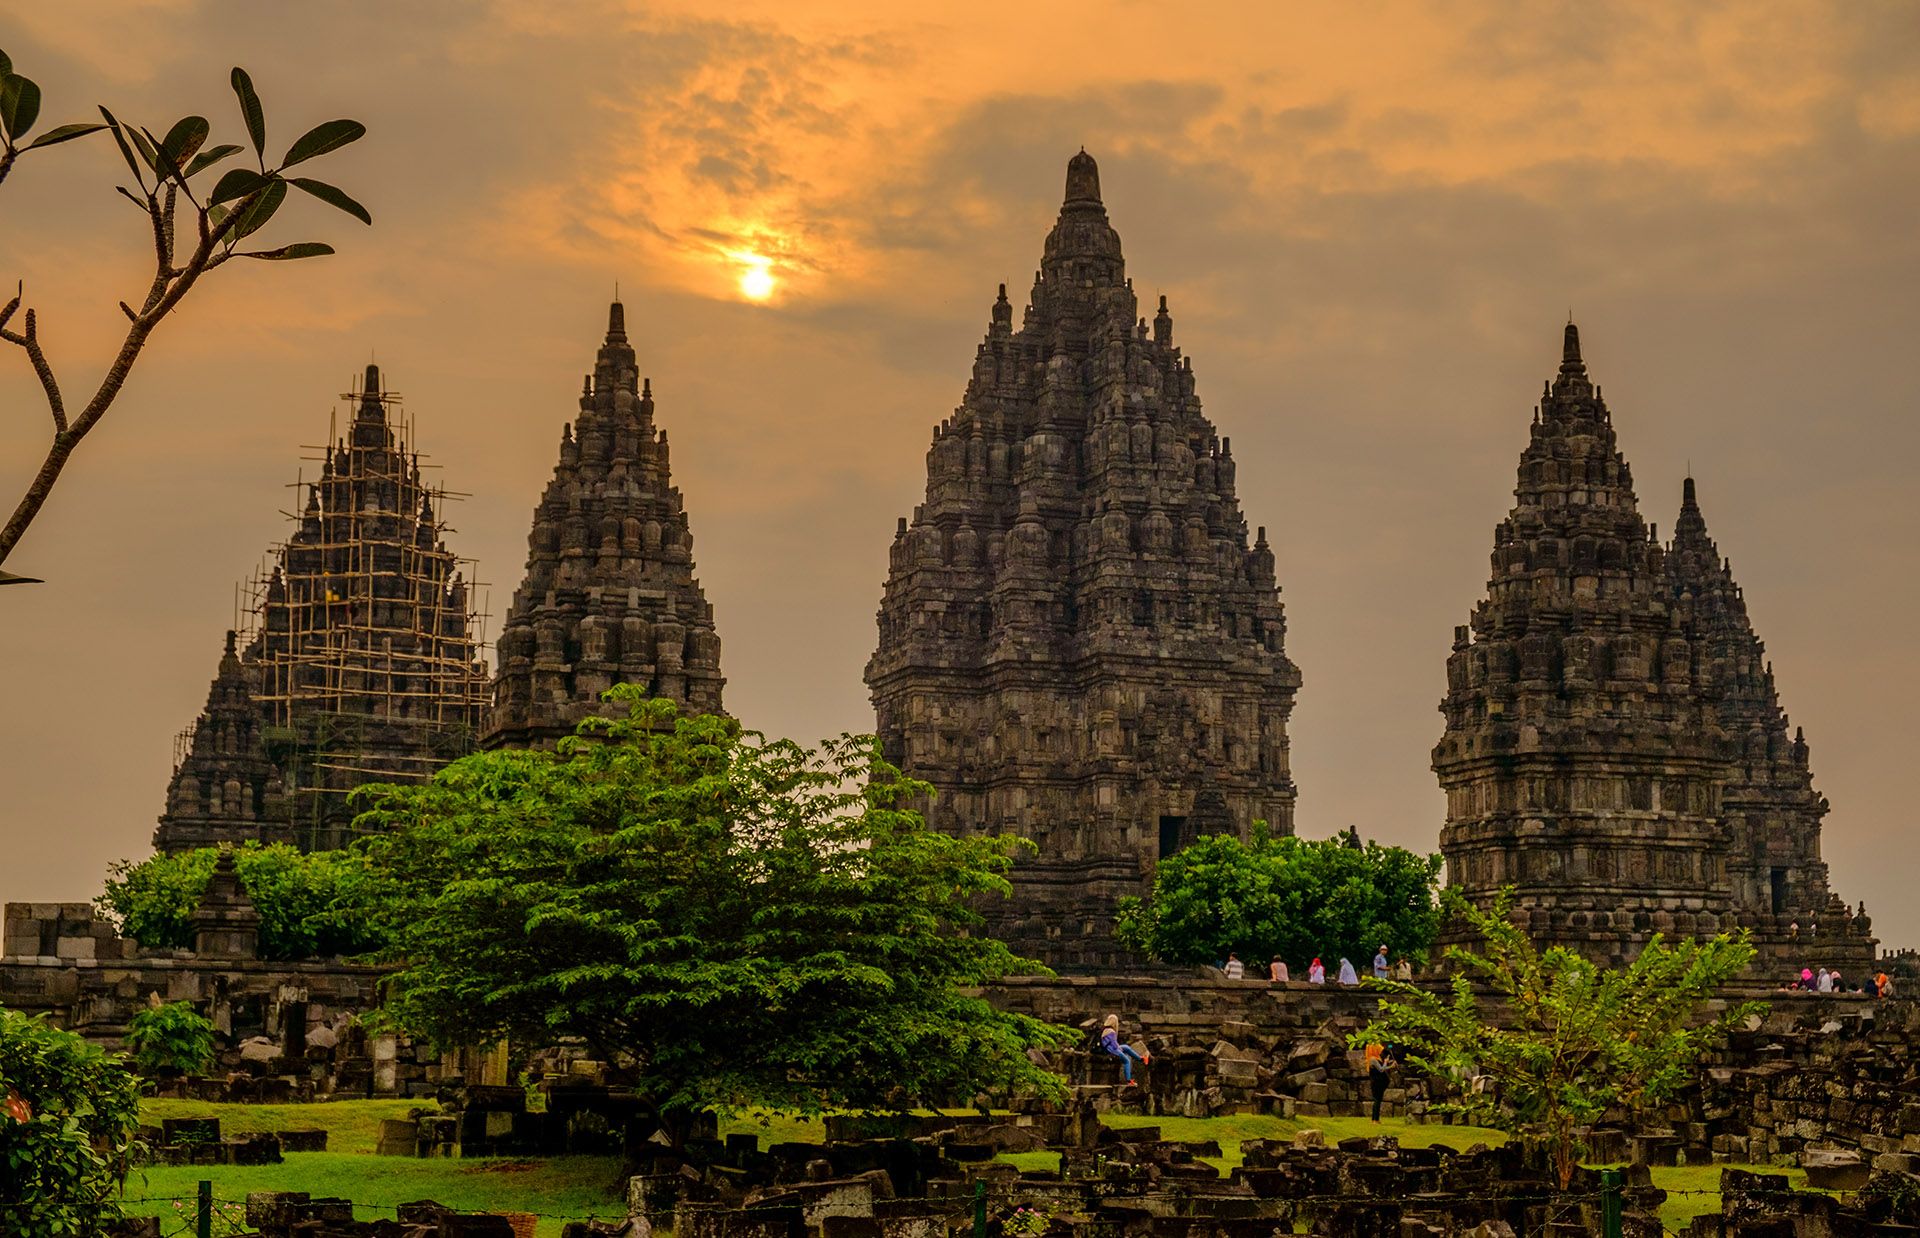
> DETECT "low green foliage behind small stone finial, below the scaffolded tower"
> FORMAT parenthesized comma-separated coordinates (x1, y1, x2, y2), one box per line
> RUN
(100, 843, 382, 960)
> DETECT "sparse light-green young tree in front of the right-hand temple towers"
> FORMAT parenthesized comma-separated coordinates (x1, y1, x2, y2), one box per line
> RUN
(1352, 891, 1766, 1190)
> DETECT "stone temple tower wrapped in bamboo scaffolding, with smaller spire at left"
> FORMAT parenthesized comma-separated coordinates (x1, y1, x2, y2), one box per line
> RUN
(154, 365, 488, 852)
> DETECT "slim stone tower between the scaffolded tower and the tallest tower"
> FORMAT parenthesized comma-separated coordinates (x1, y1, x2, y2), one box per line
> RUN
(484, 301, 726, 749)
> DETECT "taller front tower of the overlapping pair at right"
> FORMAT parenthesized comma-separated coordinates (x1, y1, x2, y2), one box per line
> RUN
(1434, 322, 1734, 962)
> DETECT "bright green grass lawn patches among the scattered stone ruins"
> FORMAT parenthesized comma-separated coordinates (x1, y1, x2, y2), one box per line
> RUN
(127, 1100, 1807, 1238)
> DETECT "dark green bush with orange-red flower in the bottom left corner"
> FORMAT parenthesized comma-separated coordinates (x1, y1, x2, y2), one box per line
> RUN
(0, 1008, 140, 1238)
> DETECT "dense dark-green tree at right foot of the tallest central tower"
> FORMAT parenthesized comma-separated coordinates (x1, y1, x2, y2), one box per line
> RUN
(1117, 821, 1440, 979)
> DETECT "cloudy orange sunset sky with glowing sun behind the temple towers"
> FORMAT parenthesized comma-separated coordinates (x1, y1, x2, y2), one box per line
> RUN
(0, 0, 1920, 946)
